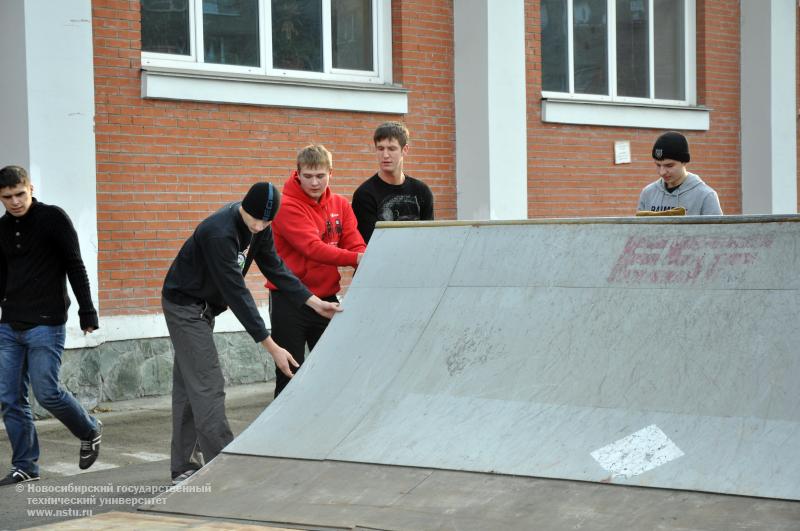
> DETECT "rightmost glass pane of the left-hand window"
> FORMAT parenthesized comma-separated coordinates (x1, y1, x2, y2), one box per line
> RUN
(331, 0, 372, 71)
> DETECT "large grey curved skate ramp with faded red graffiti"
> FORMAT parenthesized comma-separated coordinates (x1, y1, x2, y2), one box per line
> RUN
(144, 216, 800, 531)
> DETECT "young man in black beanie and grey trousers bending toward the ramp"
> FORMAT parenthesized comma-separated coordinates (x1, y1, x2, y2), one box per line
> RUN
(161, 182, 341, 484)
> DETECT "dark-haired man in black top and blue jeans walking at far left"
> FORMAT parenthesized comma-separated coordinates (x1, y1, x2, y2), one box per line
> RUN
(0, 166, 102, 485)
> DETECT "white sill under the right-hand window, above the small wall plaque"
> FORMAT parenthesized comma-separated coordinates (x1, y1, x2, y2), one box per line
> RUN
(542, 98, 711, 131)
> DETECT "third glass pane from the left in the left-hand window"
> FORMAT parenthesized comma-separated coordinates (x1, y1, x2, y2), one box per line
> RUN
(272, 0, 322, 72)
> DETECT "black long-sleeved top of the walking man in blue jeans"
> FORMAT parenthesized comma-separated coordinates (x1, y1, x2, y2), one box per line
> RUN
(0, 198, 98, 329)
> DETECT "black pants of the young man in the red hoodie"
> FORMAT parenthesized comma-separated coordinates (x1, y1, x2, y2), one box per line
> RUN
(269, 291, 338, 396)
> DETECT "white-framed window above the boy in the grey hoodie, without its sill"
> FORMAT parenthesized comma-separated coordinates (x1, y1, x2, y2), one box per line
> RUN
(541, 0, 695, 106)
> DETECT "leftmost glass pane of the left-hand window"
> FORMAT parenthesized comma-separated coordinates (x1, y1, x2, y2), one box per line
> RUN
(141, 0, 191, 55)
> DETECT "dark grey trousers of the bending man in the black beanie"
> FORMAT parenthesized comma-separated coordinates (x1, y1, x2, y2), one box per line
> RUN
(161, 297, 233, 478)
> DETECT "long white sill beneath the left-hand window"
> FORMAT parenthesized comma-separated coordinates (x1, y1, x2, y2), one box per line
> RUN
(142, 68, 408, 114)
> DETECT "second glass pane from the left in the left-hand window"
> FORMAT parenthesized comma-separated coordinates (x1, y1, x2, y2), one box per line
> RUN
(203, 0, 260, 66)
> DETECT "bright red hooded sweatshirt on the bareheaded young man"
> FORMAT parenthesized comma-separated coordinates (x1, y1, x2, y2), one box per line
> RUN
(266, 170, 367, 297)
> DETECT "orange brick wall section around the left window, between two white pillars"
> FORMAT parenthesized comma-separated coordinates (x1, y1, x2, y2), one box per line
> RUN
(92, 0, 456, 316)
